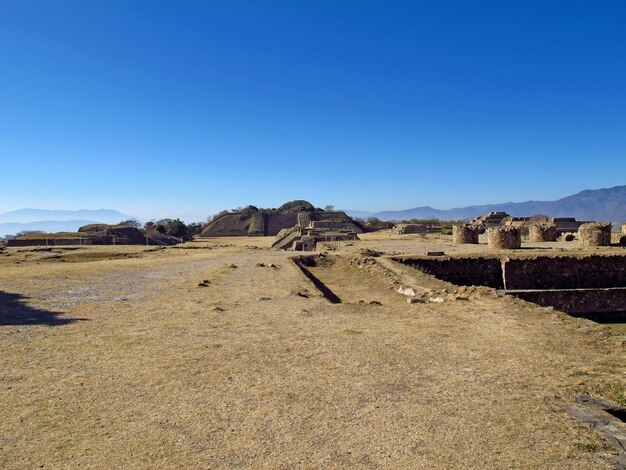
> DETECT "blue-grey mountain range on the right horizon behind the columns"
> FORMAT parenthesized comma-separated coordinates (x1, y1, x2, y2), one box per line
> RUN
(346, 186, 626, 225)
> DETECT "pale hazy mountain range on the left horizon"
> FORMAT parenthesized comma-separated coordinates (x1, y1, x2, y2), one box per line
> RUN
(0, 209, 145, 237)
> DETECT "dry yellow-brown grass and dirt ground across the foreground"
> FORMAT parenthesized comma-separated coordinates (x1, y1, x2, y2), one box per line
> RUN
(0, 233, 626, 469)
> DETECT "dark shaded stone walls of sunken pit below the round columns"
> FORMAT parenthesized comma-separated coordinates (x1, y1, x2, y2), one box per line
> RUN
(392, 253, 626, 322)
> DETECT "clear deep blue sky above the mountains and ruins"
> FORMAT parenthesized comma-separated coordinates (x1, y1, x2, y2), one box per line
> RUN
(0, 0, 626, 219)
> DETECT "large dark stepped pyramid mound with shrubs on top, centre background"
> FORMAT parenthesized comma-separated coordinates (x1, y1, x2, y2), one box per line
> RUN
(199, 200, 365, 238)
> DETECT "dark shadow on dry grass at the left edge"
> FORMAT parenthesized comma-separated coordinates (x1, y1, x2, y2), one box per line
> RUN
(0, 291, 86, 326)
